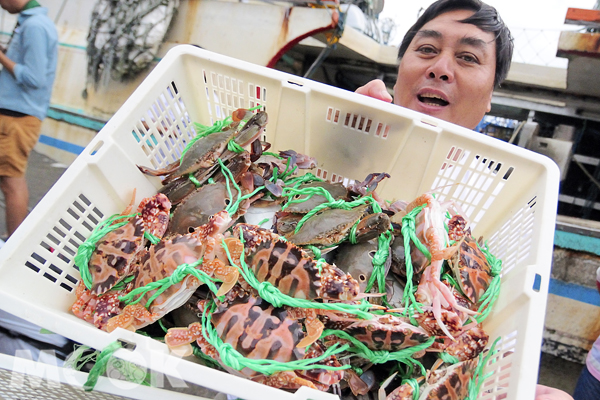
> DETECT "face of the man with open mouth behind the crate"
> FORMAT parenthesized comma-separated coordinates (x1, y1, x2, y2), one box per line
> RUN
(394, 10, 496, 129)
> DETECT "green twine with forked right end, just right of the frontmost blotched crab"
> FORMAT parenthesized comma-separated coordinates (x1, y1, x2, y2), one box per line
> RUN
(321, 329, 435, 375)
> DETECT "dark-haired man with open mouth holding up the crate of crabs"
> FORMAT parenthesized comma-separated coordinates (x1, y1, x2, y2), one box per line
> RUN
(356, 0, 572, 400)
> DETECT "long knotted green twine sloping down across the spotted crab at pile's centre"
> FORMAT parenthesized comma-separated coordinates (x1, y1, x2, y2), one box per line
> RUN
(222, 236, 373, 319)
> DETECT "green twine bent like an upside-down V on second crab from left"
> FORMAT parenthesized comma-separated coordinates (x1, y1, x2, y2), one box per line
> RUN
(119, 259, 223, 308)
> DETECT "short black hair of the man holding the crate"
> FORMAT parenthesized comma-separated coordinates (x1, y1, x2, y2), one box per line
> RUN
(398, 0, 513, 87)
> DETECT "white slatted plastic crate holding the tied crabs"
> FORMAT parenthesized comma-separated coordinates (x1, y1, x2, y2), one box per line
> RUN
(0, 46, 559, 400)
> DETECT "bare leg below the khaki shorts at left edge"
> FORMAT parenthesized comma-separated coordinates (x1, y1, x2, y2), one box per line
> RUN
(0, 176, 29, 236)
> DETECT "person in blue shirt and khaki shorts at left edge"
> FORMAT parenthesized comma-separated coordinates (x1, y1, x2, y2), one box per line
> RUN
(0, 0, 58, 241)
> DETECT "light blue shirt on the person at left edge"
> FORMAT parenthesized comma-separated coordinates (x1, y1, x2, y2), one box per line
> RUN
(0, 7, 58, 120)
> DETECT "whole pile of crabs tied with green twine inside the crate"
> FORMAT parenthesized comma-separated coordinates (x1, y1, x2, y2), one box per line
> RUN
(72, 109, 500, 399)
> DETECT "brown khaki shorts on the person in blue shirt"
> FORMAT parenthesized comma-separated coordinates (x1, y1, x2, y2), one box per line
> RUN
(0, 114, 42, 178)
